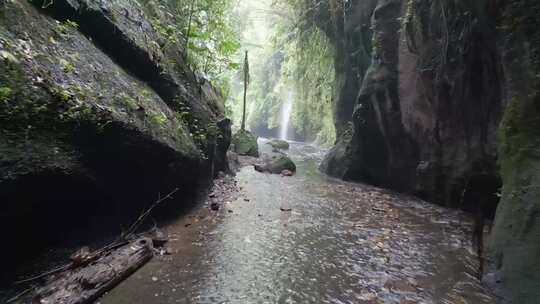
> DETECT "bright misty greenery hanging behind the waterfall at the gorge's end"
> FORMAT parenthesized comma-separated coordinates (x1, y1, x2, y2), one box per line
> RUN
(234, 0, 335, 145)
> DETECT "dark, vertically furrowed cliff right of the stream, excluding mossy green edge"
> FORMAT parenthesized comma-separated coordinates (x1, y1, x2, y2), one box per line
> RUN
(323, 0, 502, 208)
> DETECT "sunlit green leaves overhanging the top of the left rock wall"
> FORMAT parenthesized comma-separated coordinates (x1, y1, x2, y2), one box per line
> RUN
(146, 0, 240, 81)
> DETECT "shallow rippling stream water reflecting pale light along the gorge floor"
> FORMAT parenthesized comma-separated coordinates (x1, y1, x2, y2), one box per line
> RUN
(101, 143, 495, 304)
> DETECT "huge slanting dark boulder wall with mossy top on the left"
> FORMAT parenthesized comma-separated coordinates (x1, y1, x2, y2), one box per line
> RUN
(0, 0, 231, 270)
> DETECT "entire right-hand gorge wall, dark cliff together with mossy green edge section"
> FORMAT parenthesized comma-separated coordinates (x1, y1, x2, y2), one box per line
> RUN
(321, 0, 540, 303)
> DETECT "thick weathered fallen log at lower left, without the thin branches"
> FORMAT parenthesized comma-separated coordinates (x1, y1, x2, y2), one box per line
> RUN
(32, 238, 154, 304)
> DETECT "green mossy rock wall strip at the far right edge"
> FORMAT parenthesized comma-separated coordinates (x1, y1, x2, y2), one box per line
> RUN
(489, 1, 540, 304)
